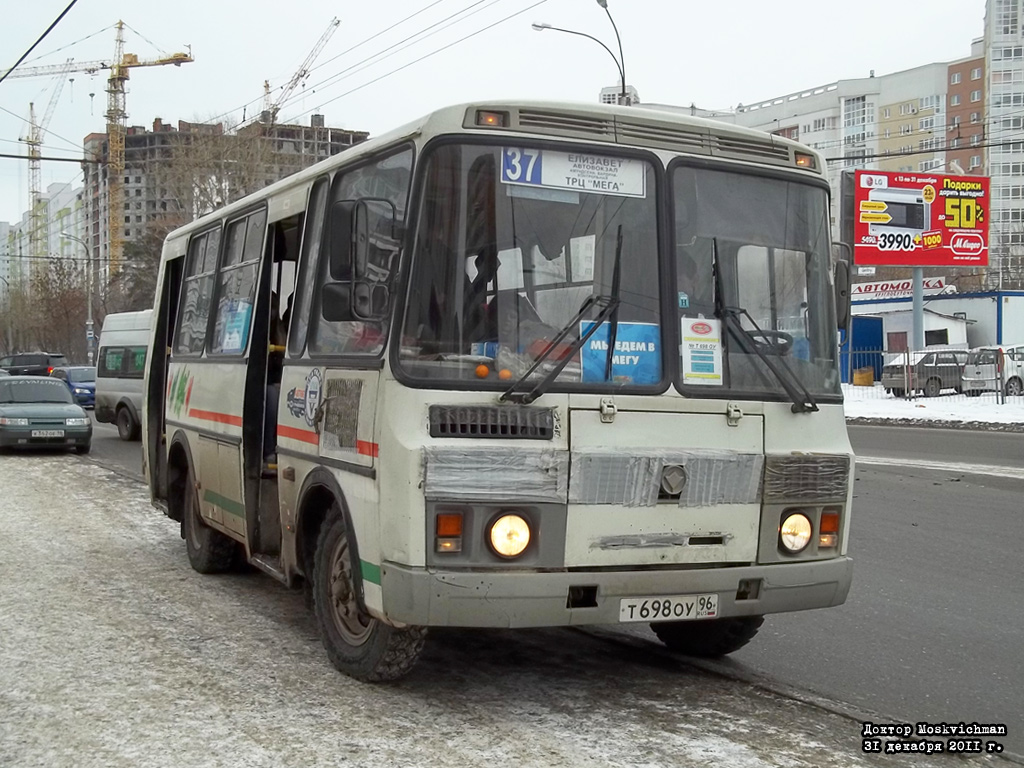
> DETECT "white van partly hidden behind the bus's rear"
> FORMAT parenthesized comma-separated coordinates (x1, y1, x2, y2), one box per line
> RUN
(95, 309, 153, 440)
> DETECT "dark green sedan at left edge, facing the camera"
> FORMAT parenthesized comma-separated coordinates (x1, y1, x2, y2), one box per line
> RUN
(0, 376, 92, 454)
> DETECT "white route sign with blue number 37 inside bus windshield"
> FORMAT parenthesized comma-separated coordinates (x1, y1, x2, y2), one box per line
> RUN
(502, 146, 647, 198)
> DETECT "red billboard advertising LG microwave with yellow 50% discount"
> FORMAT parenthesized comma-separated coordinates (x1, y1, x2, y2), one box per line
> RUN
(853, 171, 988, 266)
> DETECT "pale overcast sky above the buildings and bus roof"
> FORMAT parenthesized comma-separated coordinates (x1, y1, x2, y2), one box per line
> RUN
(0, 0, 985, 223)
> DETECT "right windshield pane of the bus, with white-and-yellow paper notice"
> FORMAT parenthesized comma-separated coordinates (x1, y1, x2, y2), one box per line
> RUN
(672, 166, 841, 402)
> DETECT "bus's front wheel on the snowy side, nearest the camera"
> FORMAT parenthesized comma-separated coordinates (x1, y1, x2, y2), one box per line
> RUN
(312, 505, 427, 682)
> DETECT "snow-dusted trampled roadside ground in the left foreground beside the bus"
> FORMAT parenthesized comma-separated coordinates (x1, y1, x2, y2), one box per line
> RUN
(0, 456, 999, 768)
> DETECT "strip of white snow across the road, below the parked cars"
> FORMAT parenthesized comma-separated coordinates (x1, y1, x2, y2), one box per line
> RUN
(843, 384, 1024, 429)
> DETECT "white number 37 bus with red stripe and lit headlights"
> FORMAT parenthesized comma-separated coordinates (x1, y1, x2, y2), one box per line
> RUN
(142, 101, 853, 681)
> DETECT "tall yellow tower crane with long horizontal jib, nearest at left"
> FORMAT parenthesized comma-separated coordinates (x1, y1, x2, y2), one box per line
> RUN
(7, 20, 195, 273)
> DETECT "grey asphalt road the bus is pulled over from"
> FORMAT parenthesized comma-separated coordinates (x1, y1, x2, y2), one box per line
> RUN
(74, 425, 1024, 755)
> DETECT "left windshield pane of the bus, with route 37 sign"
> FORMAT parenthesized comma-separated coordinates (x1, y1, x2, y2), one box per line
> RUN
(398, 143, 663, 390)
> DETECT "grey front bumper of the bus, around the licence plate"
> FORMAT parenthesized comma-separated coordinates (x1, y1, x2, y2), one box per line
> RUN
(381, 557, 853, 628)
